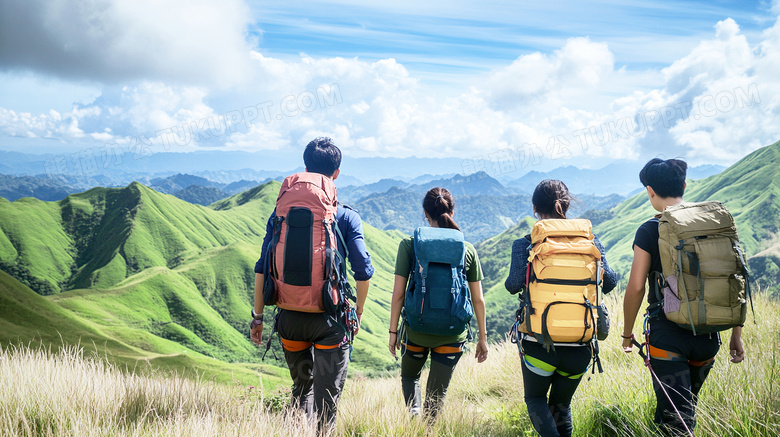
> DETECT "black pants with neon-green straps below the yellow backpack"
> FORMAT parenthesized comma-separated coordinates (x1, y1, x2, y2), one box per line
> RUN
(521, 340, 592, 437)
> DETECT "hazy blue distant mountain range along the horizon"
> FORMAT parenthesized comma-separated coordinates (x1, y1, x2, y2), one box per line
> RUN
(0, 147, 723, 190)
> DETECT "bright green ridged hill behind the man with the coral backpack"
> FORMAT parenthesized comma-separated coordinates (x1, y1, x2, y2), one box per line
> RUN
(0, 178, 402, 382)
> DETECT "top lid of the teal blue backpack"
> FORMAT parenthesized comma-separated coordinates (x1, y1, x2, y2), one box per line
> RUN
(414, 226, 466, 274)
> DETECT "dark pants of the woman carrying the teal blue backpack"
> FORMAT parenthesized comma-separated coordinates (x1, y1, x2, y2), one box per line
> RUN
(401, 340, 463, 420)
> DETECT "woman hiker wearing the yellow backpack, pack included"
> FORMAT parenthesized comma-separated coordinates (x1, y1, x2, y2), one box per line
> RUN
(504, 179, 617, 437)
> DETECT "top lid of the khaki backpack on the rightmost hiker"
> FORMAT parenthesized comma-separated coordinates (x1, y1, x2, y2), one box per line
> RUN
(658, 201, 737, 240)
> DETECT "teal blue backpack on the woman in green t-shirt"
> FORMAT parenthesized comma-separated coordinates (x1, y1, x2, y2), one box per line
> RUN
(404, 227, 474, 335)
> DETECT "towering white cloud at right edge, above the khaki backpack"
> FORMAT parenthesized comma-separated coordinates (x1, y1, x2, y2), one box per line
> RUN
(628, 19, 780, 164)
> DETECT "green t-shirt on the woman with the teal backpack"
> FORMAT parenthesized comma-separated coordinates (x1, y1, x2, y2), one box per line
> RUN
(395, 237, 484, 348)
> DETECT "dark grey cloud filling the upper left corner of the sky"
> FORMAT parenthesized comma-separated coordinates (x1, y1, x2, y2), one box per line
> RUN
(0, 0, 251, 87)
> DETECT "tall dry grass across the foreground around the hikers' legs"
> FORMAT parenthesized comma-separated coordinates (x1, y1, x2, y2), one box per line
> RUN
(0, 290, 780, 437)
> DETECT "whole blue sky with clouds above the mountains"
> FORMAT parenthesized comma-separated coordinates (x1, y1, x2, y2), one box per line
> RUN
(0, 0, 780, 170)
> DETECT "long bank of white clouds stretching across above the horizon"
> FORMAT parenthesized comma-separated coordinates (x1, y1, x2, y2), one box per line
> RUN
(0, 10, 780, 171)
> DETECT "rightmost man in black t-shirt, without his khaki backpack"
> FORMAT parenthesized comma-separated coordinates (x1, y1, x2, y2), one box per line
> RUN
(621, 158, 745, 436)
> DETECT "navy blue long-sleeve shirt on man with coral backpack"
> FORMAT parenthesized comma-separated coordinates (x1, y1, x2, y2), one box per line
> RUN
(255, 204, 374, 281)
